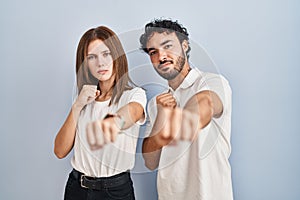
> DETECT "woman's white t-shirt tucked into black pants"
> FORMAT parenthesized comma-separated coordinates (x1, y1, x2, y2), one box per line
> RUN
(71, 87, 147, 177)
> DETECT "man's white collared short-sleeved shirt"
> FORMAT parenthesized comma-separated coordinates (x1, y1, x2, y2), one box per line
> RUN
(146, 68, 233, 200)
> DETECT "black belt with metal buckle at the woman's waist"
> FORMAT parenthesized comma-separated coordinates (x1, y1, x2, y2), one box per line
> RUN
(72, 169, 131, 190)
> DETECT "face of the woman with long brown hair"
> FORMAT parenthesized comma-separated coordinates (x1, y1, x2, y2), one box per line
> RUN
(87, 39, 114, 82)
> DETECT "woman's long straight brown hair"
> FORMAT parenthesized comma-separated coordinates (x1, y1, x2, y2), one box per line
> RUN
(76, 26, 134, 105)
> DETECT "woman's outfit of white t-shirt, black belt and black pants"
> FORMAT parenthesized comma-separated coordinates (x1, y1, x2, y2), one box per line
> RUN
(65, 87, 147, 200)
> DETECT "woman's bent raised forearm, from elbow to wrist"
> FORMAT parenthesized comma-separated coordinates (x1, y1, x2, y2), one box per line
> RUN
(54, 105, 81, 159)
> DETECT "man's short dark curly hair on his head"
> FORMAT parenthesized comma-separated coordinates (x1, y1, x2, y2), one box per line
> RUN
(140, 19, 191, 58)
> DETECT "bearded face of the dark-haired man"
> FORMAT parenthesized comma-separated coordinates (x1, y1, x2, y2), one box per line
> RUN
(147, 32, 186, 80)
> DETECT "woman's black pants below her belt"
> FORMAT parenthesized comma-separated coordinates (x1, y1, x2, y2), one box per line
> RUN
(64, 170, 135, 200)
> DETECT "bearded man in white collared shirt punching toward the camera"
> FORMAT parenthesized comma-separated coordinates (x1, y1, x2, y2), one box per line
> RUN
(140, 19, 233, 200)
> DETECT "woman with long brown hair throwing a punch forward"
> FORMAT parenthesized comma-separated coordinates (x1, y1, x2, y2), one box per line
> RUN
(54, 26, 146, 200)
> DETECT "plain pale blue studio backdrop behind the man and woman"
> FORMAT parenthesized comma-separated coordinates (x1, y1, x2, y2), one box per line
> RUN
(0, 0, 300, 200)
